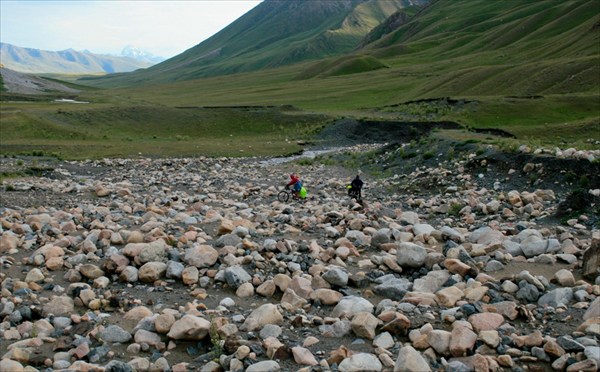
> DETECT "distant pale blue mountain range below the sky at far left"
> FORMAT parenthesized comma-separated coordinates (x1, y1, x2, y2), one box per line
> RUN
(0, 43, 156, 74)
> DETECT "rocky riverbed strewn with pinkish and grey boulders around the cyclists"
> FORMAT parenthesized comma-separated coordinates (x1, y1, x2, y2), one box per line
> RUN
(0, 142, 600, 372)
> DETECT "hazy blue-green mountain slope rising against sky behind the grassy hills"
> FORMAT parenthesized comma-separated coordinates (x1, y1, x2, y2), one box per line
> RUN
(82, 0, 428, 84)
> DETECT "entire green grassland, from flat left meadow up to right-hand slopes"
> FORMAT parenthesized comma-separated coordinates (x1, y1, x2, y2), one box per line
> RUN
(0, 0, 600, 157)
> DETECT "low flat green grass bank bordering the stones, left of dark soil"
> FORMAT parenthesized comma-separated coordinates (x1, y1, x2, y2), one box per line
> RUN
(0, 102, 330, 159)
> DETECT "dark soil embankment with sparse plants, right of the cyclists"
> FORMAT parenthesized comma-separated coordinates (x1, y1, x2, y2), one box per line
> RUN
(320, 119, 600, 226)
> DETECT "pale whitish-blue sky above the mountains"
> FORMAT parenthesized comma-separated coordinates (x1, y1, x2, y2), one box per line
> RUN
(0, 0, 260, 58)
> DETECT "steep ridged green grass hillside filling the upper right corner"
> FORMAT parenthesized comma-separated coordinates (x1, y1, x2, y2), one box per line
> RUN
(362, 0, 600, 96)
